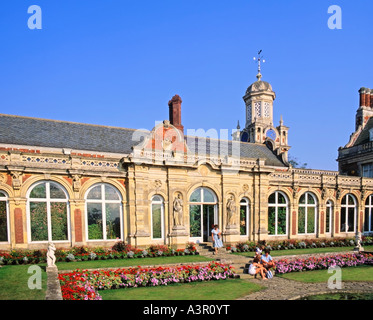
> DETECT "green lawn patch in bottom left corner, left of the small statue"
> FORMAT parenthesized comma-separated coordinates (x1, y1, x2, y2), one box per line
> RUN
(0, 265, 47, 300)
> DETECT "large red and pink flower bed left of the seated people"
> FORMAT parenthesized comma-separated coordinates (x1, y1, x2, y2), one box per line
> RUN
(58, 262, 239, 300)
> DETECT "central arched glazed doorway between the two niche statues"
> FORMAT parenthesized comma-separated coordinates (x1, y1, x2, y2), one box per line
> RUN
(189, 188, 218, 242)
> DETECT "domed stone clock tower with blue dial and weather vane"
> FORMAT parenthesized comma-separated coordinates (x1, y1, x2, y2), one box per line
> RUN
(235, 51, 290, 163)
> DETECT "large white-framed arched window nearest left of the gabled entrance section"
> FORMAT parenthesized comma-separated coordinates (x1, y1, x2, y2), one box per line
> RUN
(86, 183, 122, 240)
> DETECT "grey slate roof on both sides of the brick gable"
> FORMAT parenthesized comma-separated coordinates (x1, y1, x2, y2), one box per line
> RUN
(0, 114, 285, 167)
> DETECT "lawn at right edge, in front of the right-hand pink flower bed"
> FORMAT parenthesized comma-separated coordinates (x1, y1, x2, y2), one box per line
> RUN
(277, 265, 373, 282)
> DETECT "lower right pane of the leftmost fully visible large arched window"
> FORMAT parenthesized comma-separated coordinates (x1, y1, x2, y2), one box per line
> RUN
(50, 202, 68, 241)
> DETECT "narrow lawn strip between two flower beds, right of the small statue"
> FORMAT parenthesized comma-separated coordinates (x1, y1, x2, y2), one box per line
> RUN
(56, 255, 212, 270)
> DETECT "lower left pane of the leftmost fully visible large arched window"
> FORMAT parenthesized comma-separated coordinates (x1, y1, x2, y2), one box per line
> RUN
(30, 202, 48, 241)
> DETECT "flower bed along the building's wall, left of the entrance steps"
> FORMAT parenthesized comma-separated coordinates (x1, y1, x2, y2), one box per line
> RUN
(0, 242, 199, 265)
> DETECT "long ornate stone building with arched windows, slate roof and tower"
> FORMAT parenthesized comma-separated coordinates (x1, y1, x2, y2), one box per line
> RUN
(0, 74, 373, 249)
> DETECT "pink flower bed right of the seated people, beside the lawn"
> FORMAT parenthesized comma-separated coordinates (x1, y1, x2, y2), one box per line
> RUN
(276, 253, 373, 274)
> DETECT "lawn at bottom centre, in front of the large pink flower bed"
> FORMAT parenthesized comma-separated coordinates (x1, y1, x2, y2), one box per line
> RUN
(99, 279, 262, 300)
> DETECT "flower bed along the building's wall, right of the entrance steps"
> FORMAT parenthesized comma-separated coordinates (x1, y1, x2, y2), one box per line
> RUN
(227, 236, 373, 252)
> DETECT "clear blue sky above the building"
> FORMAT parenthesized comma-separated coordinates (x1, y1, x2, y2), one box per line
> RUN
(0, 0, 373, 170)
